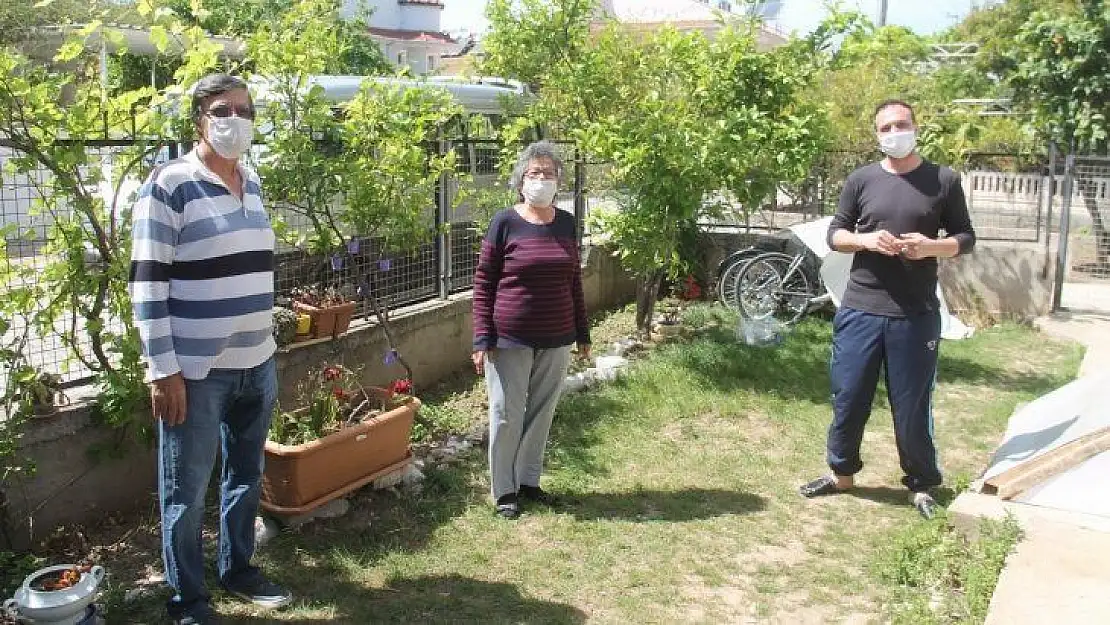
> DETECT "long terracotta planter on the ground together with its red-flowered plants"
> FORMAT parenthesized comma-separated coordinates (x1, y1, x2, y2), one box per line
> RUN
(262, 365, 421, 514)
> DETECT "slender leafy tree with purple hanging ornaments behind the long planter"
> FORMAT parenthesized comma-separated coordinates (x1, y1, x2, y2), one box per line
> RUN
(258, 67, 464, 395)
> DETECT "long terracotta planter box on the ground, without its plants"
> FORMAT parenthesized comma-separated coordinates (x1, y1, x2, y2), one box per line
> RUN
(262, 389, 421, 514)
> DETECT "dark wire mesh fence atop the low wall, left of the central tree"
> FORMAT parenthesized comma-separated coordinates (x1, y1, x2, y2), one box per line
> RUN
(0, 138, 585, 384)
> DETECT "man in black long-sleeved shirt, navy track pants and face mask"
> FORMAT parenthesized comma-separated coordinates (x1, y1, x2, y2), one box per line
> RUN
(800, 100, 975, 518)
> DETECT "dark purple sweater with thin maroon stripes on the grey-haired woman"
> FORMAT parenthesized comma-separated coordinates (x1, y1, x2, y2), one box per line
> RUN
(474, 209, 589, 350)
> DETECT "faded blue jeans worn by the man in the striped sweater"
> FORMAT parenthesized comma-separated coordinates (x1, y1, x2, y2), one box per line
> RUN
(158, 357, 278, 616)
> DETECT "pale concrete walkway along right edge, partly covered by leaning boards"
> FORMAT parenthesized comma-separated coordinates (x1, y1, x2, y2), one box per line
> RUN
(948, 312, 1110, 625)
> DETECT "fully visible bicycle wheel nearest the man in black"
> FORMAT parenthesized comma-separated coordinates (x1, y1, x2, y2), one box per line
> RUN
(733, 252, 816, 325)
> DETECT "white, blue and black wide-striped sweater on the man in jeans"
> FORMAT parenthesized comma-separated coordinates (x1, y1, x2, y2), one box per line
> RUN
(130, 151, 276, 380)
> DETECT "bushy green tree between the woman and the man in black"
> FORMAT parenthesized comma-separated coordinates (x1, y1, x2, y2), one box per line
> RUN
(482, 0, 825, 332)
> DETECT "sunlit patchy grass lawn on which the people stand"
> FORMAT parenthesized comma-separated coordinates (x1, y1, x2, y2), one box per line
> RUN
(10, 309, 1080, 624)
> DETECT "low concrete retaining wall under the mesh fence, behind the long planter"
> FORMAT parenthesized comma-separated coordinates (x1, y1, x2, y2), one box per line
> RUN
(0, 249, 636, 548)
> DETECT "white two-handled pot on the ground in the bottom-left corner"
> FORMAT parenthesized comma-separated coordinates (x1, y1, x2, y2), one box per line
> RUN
(3, 564, 104, 625)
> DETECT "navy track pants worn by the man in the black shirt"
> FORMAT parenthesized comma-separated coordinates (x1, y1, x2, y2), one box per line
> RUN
(827, 308, 942, 492)
